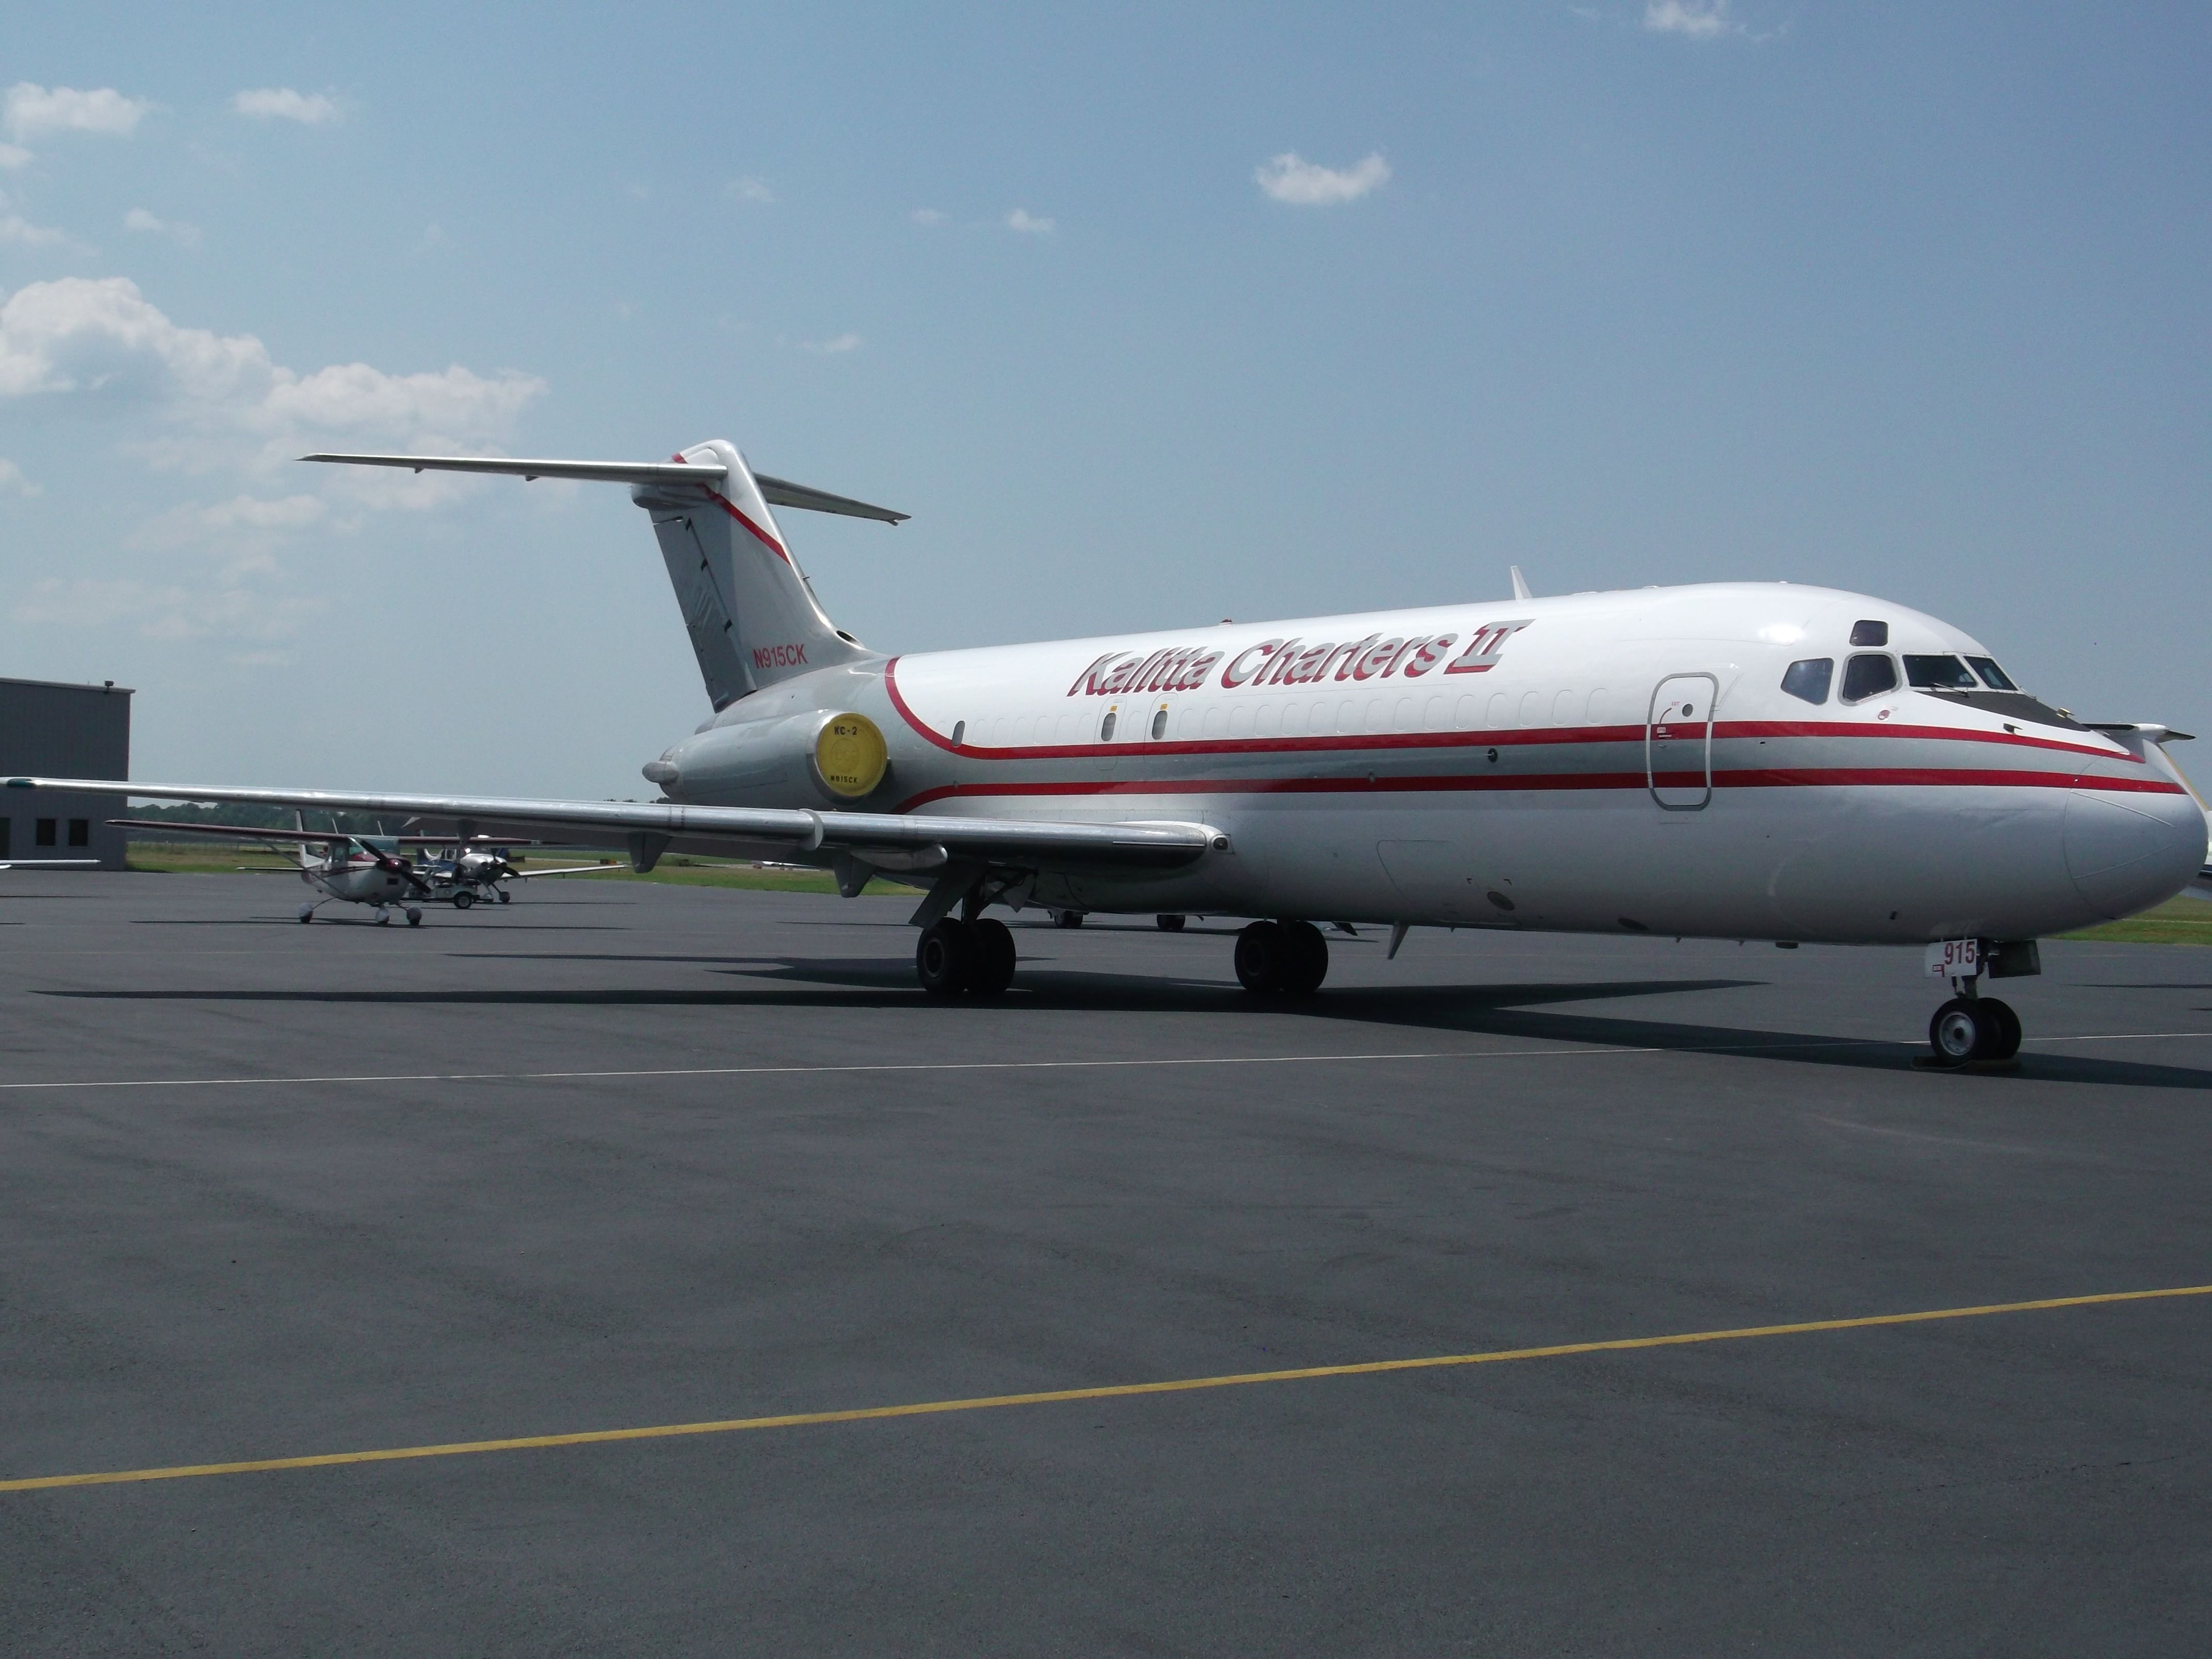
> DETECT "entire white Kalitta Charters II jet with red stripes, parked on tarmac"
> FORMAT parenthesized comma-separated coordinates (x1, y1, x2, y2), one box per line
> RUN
(13, 440, 2205, 1064)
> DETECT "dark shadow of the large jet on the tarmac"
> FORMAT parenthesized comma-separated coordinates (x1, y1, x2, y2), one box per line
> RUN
(44, 969, 2212, 1091)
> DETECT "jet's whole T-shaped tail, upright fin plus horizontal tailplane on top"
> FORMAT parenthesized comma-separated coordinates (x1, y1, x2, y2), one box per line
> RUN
(301, 438, 907, 710)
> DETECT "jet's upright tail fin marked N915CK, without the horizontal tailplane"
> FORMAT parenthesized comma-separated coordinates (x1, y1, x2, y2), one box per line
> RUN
(630, 438, 865, 710)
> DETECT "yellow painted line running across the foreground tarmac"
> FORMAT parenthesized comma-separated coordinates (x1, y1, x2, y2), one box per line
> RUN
(0, 1285, 2212, 1491)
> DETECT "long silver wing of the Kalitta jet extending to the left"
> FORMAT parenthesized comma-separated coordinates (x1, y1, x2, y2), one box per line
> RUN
(26, 778, 1228, 867)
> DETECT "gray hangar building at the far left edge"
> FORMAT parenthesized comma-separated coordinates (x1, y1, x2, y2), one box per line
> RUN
(0, 679, 131, 869)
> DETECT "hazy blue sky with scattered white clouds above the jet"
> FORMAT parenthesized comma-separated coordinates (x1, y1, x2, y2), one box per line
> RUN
(0, 0, 2212, 794)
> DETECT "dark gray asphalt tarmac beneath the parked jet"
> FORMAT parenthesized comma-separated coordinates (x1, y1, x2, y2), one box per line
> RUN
(0, 871, 2212, 1654)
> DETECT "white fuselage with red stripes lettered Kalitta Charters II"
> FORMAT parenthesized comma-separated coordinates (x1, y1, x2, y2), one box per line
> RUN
(659, 584, 2205, 945)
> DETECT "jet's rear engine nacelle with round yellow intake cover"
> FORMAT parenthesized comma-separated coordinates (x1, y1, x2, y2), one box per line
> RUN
(644, 710, 891, 807)
